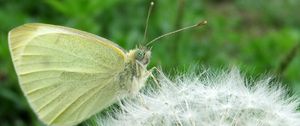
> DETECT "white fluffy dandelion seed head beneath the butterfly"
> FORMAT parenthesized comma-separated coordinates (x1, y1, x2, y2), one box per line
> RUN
(85, 70, 300, 126)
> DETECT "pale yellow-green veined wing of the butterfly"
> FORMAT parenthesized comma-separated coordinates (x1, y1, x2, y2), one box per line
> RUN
(9, 24, 126, 125)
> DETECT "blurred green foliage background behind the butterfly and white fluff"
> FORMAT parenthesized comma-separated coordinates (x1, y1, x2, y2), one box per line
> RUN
(0, 0, 300, 126)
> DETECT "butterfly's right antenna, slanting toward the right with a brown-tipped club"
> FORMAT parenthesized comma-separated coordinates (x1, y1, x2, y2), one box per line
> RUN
(146, 20, 207, 47)
